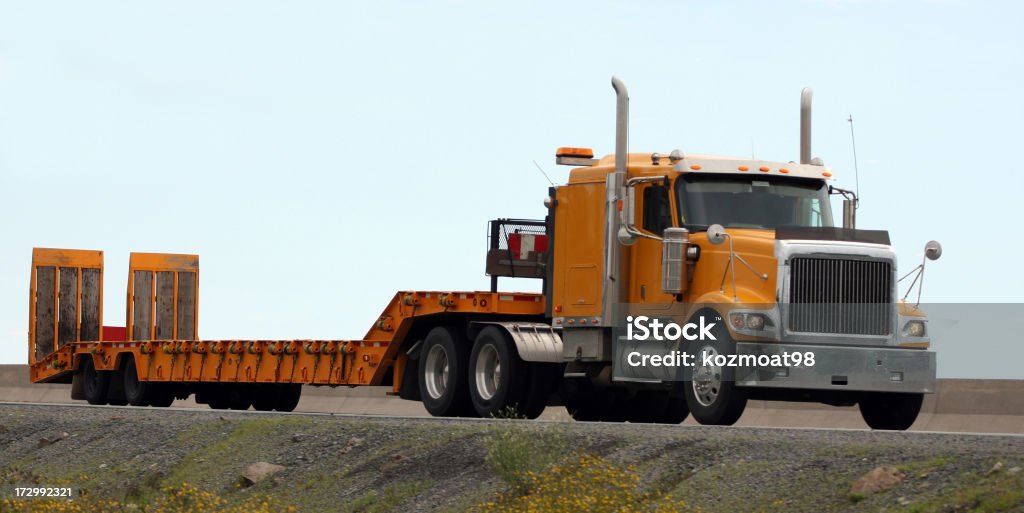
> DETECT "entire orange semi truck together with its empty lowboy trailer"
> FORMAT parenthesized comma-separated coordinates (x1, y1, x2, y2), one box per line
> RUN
(29, 78, 941, 429)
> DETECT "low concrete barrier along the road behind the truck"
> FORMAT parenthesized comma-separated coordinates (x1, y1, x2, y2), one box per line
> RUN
(0, 365, 1024, 433)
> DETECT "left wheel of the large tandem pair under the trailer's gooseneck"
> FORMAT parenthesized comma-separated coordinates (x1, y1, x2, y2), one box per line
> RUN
(419, 327, 473, 417)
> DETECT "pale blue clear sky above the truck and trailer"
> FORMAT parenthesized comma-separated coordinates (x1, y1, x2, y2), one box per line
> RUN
(0, 0, 1024, 378)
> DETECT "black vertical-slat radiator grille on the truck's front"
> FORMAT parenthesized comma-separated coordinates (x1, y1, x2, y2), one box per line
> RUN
(788, 257, 892, 335)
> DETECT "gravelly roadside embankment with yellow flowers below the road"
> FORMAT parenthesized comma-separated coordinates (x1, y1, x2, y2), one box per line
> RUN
(0, 405, 1024, 512)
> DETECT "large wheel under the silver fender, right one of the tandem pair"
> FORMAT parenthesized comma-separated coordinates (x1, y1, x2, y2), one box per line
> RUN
(469, 326, 528, 419)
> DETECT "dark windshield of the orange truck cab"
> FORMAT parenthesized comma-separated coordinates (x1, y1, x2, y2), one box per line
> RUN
(676, 173, 833, 229)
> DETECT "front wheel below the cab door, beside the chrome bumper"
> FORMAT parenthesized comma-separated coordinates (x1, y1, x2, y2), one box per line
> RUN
(683, 312, 746, 426)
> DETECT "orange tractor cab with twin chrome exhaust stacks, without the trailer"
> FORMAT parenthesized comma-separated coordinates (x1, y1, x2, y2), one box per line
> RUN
(546, 79, 935, 429)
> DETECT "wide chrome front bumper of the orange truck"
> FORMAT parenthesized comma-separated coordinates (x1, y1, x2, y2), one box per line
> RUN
(736, 342, 935, 393)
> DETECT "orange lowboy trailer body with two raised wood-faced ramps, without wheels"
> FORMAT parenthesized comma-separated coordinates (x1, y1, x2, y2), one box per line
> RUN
(30, 248, 545, 409)
